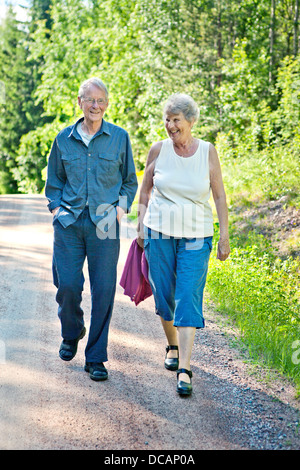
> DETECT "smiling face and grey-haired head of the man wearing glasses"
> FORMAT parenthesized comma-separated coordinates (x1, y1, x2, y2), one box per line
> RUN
(78, 84, 108, 126)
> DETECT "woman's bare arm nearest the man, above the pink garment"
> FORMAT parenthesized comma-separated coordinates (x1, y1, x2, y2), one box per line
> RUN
(137, 142, 162, 248)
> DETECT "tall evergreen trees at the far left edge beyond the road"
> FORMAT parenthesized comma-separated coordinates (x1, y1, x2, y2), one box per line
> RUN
(0, 1, 52, 194)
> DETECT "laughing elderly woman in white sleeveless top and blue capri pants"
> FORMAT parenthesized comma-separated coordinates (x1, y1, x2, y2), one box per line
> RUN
(137, 94, 230, 395)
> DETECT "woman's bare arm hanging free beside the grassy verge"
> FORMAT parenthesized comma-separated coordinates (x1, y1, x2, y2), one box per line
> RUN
(209, 144, 230, 261)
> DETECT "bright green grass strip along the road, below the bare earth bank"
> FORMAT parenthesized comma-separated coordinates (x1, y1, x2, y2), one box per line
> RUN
(207, 237, 300, 396)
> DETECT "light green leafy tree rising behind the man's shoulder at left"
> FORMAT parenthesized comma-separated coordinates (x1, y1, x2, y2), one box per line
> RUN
(14, 0, 92, 192)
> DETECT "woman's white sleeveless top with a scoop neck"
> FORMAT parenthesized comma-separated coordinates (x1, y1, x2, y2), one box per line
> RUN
(144, 139, 213, 238)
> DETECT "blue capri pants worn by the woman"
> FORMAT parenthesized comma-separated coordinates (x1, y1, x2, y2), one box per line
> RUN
(144, 227, 212, 328)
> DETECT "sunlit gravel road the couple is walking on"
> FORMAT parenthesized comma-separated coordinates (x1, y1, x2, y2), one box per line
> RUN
(0, 196, 300, 451)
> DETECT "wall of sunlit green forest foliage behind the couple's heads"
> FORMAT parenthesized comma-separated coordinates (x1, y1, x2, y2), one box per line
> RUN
(0, 0, 299, 186)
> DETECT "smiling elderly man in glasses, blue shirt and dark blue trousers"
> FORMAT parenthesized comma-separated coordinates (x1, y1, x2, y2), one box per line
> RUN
(45, 78, 137, 380)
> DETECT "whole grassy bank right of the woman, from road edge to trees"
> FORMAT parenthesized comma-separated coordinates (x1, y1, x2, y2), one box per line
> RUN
(207, 143, 300, 397)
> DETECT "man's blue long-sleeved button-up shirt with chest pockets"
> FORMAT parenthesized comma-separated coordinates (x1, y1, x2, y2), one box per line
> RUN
(45, 118, 137, 227)
